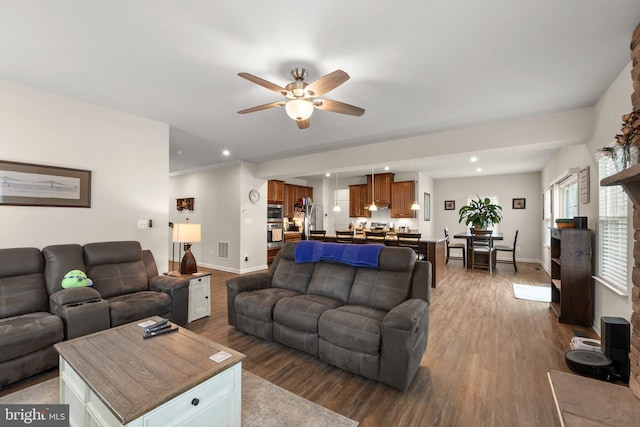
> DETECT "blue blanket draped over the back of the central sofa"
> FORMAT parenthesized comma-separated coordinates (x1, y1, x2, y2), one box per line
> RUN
(295, 240, 384, 268)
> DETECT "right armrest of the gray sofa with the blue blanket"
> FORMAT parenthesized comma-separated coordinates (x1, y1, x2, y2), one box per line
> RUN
(380, 298, 429, 390)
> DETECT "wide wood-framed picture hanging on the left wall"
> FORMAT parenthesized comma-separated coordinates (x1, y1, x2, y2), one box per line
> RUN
(0, 160, 91, 208)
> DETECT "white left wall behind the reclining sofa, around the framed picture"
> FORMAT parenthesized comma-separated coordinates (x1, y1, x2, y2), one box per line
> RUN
(0, 80, 169, 271)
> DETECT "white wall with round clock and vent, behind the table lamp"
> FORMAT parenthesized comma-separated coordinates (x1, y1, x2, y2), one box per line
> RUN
(168, 162, 267, 273)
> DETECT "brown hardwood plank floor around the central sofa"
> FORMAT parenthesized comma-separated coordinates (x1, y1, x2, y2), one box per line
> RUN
(0, 261, 596, 427)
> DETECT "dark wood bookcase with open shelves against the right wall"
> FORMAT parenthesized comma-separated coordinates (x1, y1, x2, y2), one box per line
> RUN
(550, 228, 592, 326)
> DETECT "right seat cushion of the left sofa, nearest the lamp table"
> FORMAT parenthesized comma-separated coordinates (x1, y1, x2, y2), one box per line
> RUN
(108, 291, 171, 327)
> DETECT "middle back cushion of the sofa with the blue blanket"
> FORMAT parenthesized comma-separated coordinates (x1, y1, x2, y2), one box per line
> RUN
(307, 262, 357, 304)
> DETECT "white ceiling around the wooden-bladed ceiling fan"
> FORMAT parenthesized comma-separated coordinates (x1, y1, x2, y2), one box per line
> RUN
(0, 0, 640, 178)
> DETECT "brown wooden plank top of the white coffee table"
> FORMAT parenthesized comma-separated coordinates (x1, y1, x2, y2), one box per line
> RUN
(54, 316, 246, 424)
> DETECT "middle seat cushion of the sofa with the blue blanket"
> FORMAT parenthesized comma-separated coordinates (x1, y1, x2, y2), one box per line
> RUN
(273, 295, 342, 334)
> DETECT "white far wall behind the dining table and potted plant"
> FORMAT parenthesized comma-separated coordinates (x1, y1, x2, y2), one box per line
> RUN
(433, 173, 542, 262)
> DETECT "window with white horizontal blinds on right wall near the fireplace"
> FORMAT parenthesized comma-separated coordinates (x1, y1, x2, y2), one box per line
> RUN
(597, 157, 629, 294)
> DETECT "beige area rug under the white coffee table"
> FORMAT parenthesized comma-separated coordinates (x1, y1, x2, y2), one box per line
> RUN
(0, 370, 358, 427)
